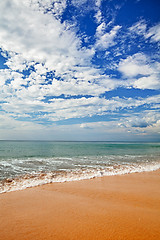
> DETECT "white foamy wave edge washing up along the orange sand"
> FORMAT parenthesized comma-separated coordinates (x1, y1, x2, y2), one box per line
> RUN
(0, 162, 160, 193)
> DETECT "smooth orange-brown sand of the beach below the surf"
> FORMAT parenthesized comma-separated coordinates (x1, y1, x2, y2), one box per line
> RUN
(0, 171, 160, 240)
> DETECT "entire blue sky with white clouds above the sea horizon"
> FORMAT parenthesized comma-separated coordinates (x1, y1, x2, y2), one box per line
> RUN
(0, 0, 160, 141)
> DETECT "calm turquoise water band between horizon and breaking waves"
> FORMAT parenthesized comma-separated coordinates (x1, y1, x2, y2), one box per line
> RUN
(0, 141, 160, 159)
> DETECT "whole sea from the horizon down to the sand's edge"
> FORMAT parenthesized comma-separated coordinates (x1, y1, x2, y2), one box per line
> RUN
(0, 141, 160, 193)
